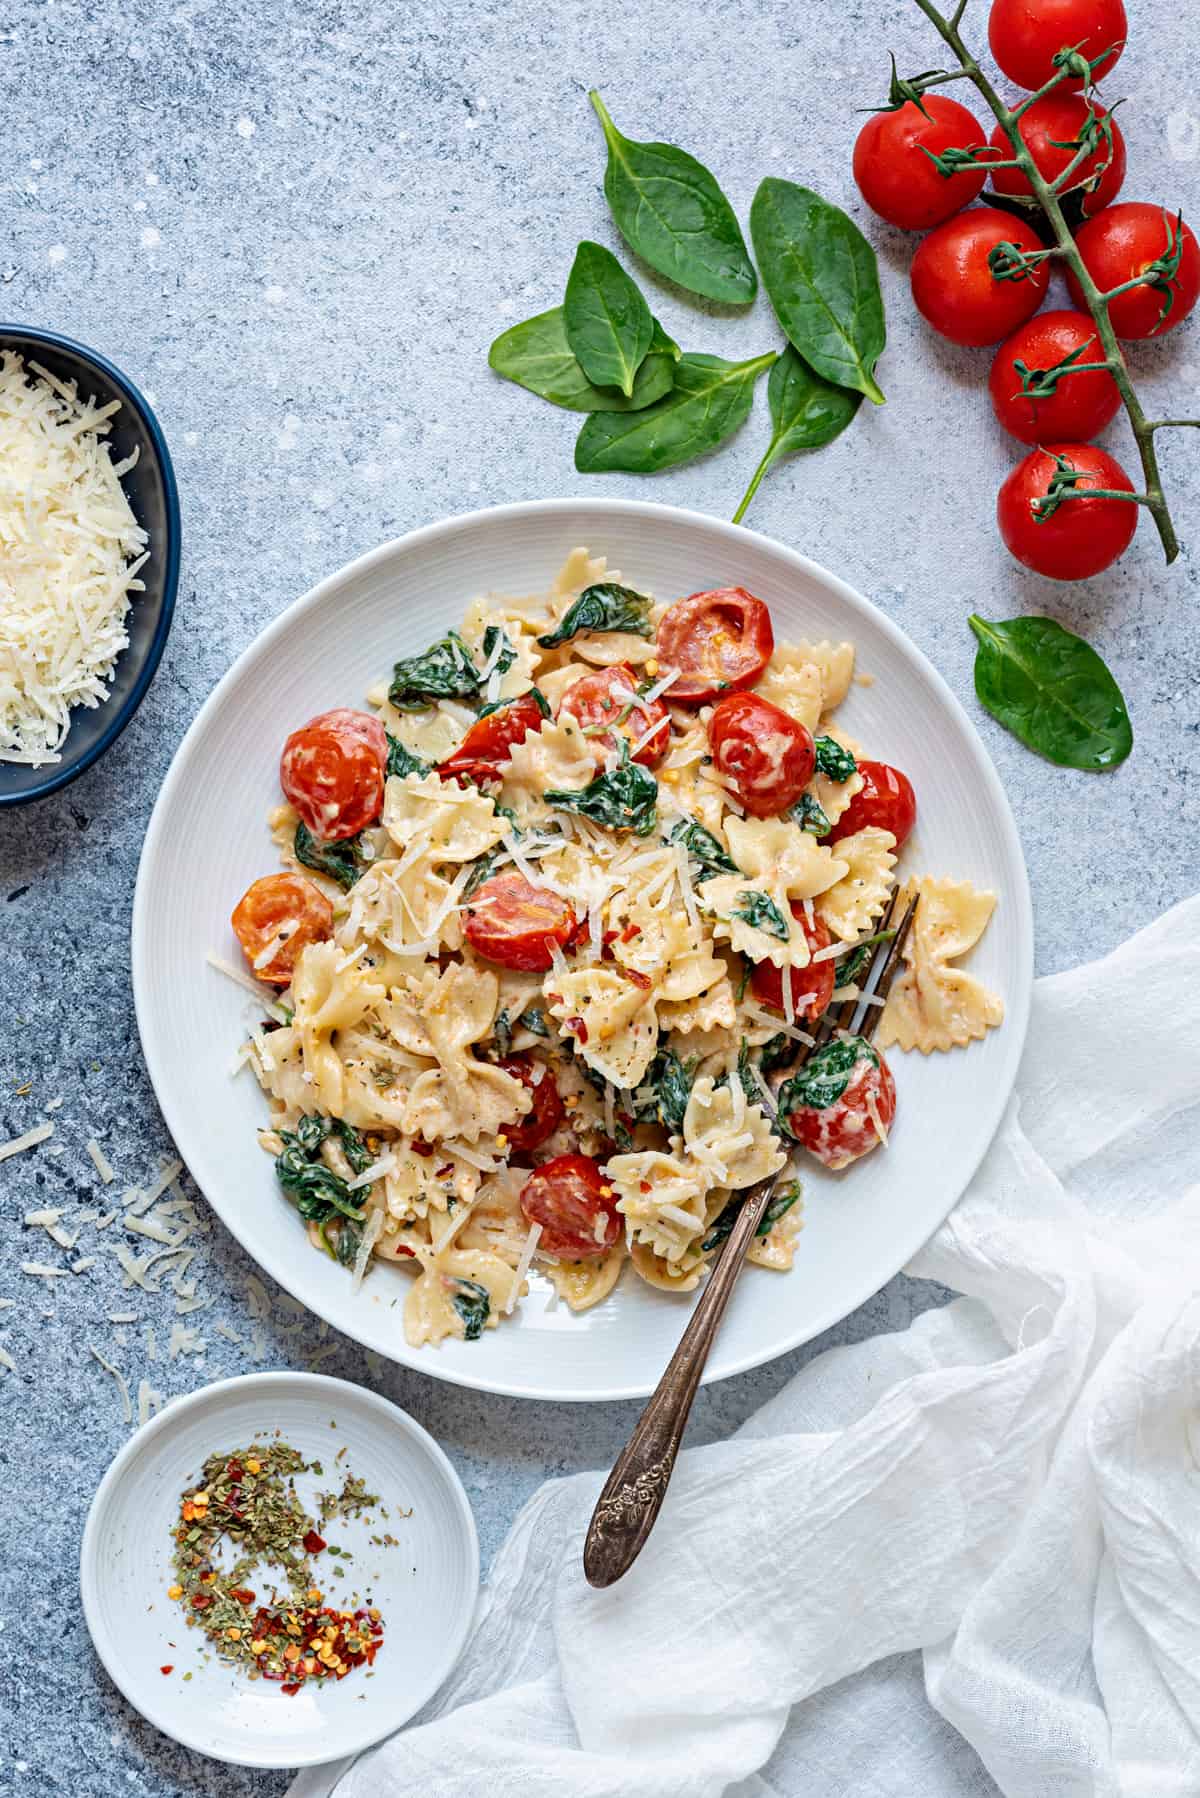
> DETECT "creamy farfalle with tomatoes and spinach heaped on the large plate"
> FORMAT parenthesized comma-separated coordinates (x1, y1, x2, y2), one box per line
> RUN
(223, 548, 1002, 1345)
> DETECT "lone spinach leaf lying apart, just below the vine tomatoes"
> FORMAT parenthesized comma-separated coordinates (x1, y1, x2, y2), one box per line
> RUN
(968, 613, 1133, 771)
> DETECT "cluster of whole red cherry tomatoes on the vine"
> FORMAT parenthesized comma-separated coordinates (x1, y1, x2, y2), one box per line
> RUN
(855, 0, 1200, 581)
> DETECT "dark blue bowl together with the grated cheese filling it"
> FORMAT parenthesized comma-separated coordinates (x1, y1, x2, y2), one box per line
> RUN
(0, 325, 180, 807)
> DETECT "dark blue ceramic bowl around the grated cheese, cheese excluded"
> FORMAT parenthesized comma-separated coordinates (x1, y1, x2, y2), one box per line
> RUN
(0, 324, 180, 807)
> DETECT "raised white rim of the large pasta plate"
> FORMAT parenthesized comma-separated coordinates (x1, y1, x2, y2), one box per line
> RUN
(130, 496, 1033, 1404)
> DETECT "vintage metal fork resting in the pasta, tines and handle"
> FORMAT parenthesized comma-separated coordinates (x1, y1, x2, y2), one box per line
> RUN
(583, 888, 918, 1586)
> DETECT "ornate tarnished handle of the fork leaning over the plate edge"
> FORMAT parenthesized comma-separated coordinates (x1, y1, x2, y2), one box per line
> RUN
(583, 1176, 777, 1586)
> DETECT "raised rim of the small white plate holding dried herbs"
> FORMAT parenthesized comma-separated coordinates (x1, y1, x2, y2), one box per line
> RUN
(79, 1368, 480, 1767)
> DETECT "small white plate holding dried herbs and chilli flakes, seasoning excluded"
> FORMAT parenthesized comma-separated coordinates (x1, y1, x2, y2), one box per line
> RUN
(79, 1374, 479, 1767)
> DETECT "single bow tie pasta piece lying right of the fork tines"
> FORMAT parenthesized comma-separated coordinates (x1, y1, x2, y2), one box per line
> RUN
(876, 876, 1004, 1055)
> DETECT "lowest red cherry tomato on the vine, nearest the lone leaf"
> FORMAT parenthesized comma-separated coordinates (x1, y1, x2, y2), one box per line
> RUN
(997, 444, 1137, 581)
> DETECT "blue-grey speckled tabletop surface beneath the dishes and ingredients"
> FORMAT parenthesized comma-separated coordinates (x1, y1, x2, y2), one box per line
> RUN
(0, 0, 1200, 1798)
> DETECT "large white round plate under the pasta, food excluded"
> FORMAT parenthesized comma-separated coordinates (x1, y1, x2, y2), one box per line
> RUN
(133, 500, 1033, 1399)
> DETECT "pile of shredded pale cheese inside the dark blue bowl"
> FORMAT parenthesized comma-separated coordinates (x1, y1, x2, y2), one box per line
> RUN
(0, 351, 148, 768)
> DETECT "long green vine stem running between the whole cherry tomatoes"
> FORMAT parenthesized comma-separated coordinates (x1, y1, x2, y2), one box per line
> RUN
(914, 0, 1200, 563)
